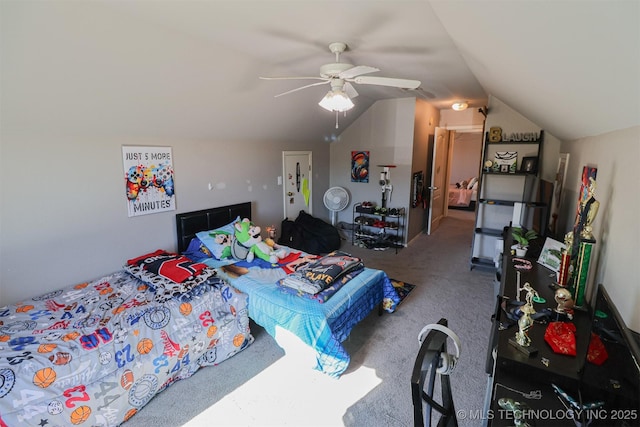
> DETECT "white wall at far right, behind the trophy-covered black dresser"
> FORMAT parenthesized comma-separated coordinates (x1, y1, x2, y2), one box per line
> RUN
(558, 126, 640, 332)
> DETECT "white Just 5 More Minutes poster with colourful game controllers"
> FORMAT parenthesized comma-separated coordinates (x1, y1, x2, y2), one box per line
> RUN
(122, 145, 176, 217)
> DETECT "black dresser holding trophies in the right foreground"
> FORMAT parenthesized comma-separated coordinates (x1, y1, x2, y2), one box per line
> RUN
(482, 228, 640, 427)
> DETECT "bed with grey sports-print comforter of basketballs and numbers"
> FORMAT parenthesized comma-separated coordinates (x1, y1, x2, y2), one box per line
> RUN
(0, 252, 253, 426)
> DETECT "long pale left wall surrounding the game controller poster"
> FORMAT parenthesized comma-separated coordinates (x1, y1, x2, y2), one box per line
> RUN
(0, 132, 329, 306)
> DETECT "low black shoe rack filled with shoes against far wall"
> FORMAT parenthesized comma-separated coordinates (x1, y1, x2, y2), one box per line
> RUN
(351, 203, 405, 253)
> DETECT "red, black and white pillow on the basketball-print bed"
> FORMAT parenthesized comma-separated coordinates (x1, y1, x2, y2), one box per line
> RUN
(123, 250, 216, 295)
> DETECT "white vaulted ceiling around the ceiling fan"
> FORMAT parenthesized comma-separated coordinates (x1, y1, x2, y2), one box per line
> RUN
(1, 0, 640, 145)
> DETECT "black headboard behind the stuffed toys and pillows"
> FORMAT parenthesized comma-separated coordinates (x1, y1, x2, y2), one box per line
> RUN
(176, 202, 251, 253)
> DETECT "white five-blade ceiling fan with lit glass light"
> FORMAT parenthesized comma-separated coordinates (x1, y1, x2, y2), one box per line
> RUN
(260, 42, 420, 112)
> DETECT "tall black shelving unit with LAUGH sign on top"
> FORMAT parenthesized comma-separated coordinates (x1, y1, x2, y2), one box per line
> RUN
(470, 130, 546, 269)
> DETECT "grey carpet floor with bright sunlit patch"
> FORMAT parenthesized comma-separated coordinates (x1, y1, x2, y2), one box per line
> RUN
(123, 213, 495, 427)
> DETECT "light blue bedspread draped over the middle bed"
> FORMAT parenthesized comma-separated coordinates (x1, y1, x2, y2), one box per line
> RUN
(210, 259, 400, 377)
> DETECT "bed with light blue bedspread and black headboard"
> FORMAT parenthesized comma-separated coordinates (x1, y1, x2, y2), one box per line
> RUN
(176, 202, 400, 378)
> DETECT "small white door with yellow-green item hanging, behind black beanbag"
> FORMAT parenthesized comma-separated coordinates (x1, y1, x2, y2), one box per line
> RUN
(282, 151, 313, 221)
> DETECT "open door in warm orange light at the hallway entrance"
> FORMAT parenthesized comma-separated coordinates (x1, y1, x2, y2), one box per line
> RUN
(427, 127, 449, 234)
